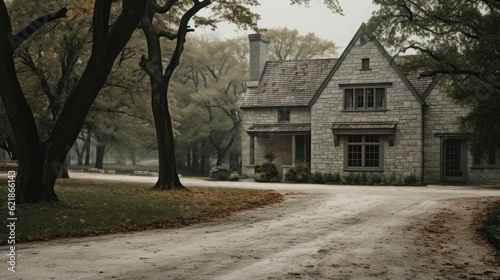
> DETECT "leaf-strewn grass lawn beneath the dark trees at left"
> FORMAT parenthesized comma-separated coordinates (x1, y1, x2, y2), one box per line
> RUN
(0, 179, 282, 245)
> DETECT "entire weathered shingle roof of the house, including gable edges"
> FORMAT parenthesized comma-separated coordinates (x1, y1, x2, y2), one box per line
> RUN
(240, 24, 437, 108)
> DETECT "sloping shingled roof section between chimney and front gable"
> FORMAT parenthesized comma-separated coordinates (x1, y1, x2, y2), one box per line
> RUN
(241, 59, 338, 108)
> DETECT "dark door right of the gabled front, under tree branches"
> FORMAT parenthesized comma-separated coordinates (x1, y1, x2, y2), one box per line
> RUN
(441, 138, 467, 182)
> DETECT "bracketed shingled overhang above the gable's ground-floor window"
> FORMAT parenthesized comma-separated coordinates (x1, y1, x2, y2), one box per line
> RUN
(331, 122, 398, 146)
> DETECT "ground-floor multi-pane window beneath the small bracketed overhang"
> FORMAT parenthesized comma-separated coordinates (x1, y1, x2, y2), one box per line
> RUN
(346, 135, 382, 169)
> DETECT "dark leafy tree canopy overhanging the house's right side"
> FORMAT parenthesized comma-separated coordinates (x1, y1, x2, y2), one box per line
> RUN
(367, 0, 500, 153)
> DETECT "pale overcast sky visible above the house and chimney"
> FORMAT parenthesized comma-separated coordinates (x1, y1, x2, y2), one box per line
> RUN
(196, 0, 376, 51)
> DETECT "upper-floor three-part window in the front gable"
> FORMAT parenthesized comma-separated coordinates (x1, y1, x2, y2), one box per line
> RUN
(344, 88, 386, 110)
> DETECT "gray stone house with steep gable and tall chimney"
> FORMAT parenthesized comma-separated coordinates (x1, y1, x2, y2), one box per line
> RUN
(240, 28, 500, 183)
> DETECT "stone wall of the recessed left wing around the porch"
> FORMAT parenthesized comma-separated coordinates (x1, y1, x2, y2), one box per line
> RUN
(241, 108, 311, 177)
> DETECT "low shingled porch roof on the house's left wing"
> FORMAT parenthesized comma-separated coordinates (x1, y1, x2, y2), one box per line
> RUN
(247, 123, 311, 136)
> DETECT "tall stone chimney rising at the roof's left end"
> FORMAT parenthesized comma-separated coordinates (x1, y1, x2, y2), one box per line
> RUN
(247, 34, 271, 87)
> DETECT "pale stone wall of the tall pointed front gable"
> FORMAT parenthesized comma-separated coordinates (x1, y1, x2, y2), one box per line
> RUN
(311, 36, 422, 178)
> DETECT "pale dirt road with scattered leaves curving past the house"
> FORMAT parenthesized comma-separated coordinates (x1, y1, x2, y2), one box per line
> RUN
(0, 176, 500, 280)
